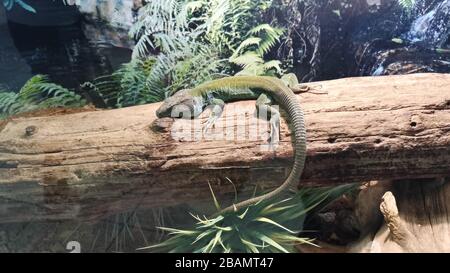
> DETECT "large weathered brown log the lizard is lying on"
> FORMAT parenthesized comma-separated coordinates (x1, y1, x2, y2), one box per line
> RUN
(0, 74, 450, 222)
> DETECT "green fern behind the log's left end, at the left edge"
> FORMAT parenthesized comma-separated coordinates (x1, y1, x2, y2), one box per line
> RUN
(0, 75, 86, 118)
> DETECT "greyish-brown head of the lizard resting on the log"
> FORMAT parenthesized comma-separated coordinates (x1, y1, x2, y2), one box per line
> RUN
(156, 89, 203, 118)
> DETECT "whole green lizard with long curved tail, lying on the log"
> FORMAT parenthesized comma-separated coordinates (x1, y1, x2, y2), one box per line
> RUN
(156, 76, 307, 213)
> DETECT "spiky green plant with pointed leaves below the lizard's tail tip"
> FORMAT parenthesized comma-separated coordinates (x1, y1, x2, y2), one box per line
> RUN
(141, 185, 355, 253)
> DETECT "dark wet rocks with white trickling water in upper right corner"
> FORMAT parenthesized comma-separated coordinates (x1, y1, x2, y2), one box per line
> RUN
(354, 0, 450, 76)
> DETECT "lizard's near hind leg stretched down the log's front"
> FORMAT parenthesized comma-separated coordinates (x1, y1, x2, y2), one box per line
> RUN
(256, 94, 280, 151)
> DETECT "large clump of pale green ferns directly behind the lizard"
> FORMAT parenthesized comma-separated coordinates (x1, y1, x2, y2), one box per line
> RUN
(123, 0, 282, 102)
